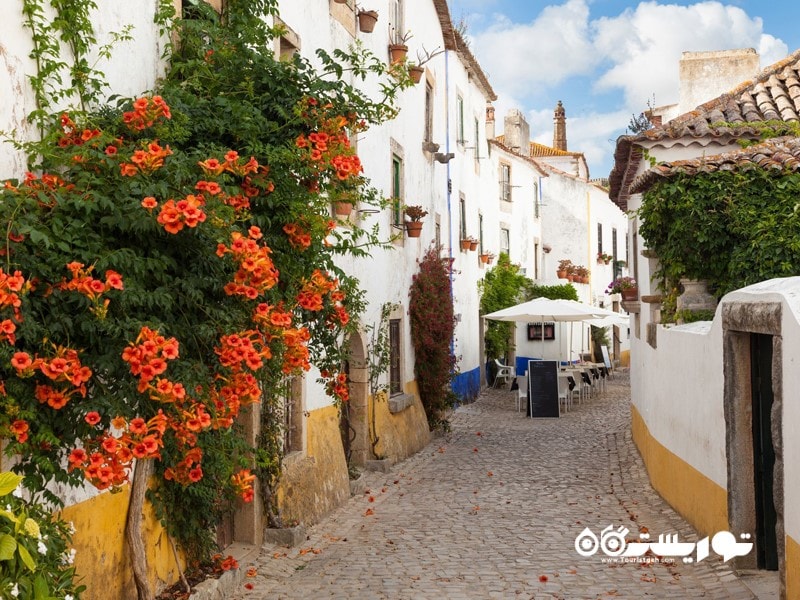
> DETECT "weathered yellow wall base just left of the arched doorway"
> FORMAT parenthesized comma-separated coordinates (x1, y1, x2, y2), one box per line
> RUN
(277, 406, 350, 526)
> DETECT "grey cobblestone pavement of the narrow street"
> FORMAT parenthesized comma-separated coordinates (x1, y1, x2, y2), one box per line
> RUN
(231, 372, 776, 600)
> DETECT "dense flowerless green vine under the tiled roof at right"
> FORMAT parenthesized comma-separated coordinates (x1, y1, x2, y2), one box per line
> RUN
(638, 168, 800, 297)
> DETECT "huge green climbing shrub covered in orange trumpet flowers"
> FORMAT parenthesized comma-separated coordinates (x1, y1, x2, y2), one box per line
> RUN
(0, 1, 404, 584)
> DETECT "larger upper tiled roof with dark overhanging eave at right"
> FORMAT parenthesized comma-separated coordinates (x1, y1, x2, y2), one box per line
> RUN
(609, 50, 800, 209)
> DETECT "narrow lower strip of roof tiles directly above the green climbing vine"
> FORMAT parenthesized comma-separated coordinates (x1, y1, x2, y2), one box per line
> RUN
(630, 136, 800, 194)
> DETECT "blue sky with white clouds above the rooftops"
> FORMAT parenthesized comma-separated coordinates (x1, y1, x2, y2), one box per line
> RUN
(448, 0, 800, 177)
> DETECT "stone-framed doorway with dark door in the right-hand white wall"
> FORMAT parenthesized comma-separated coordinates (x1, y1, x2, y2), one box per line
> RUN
(722, 301, 786, 585)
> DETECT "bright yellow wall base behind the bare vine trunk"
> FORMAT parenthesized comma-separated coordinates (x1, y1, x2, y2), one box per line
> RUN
(61, 487, 183, 600)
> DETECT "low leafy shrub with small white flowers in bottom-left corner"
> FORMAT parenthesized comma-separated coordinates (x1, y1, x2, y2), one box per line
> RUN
(0, 473, 85, 600)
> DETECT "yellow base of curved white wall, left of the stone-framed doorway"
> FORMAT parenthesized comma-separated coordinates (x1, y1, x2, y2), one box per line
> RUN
(631, 406, 728, 535)
